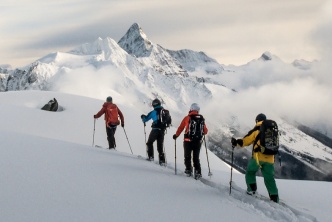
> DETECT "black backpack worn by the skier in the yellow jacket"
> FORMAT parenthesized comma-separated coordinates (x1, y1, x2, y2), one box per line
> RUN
(255, 120, 279, 155)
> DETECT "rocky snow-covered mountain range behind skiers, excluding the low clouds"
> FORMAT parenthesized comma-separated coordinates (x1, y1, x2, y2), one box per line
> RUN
(0, 23, 332, 181)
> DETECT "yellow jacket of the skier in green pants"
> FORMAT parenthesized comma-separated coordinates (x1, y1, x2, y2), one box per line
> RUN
(241, 121, 274, 165)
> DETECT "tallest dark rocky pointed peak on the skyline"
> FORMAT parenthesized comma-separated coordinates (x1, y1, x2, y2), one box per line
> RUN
(118, 23, 152, 57)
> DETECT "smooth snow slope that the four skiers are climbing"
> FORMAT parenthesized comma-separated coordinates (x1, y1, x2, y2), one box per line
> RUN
(0, 91, 332, 222)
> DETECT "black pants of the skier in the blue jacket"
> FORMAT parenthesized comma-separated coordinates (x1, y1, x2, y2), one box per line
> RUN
(146, 128, 165, 163)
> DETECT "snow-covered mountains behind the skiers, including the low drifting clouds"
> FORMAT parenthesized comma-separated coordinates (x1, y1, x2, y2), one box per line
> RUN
(0, 24, 332, 180)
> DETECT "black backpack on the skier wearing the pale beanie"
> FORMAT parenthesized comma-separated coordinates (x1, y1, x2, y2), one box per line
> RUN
(188, 115, 205, 141)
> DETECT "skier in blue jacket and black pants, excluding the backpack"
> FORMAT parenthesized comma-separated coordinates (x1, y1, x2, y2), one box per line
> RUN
(141, 99, 166, 165)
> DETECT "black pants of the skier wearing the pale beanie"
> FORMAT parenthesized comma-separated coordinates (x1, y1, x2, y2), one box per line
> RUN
(183, 141, 202, 174)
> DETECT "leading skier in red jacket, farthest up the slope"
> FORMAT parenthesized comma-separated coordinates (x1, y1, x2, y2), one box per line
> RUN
(93, 96, 124, 149)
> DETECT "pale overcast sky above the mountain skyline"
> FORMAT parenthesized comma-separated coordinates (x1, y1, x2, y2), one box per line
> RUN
(0, 0, 332, 68)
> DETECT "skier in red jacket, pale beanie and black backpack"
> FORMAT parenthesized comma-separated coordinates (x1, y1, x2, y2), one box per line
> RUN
(173, 103, 208, 179)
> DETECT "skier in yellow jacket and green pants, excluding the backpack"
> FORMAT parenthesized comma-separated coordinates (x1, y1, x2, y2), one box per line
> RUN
(231, 113, 279, 203)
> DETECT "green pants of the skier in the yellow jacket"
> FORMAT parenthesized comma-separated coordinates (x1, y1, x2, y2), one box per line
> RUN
(246, 158, 278, 195)
